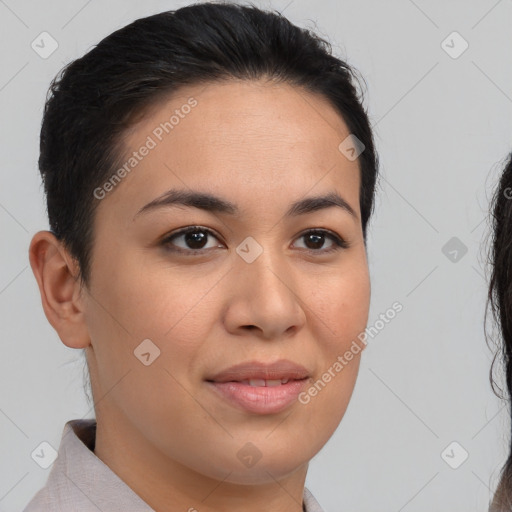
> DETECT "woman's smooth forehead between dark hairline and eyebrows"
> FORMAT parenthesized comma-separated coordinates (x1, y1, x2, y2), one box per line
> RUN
(97, 81, 359, 218)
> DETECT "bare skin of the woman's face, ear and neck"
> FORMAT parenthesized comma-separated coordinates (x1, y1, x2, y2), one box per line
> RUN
(30, 81, 370, 512)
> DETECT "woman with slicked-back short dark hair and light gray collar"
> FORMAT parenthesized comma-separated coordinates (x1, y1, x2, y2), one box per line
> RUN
(25, 3, 378, 512)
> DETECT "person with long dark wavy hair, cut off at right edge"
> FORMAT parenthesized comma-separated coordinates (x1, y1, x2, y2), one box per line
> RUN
(488, 153, 512, 512)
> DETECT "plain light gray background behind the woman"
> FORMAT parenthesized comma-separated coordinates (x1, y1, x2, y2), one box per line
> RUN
(0, 0, 512, 512)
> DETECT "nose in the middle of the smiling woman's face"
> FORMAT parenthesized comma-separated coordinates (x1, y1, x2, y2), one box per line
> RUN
(224, 246, 306, 340)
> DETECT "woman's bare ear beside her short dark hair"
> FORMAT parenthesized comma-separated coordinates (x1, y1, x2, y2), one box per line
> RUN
(29, 231, 91, 348)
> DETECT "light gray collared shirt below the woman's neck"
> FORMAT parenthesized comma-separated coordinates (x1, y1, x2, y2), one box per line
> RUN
(23, 419, 323, 512)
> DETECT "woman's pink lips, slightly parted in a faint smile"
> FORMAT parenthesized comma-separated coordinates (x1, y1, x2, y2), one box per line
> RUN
(206, 359, 310, 414)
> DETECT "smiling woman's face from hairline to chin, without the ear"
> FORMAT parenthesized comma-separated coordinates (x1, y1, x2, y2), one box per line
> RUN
(81, 81, 370, 483)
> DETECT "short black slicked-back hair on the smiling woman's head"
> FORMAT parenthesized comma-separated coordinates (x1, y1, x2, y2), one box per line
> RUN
(39, 2, 378, 284)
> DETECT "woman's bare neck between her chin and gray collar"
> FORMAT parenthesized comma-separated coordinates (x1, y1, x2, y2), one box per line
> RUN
(94, 409, 308, 512)
